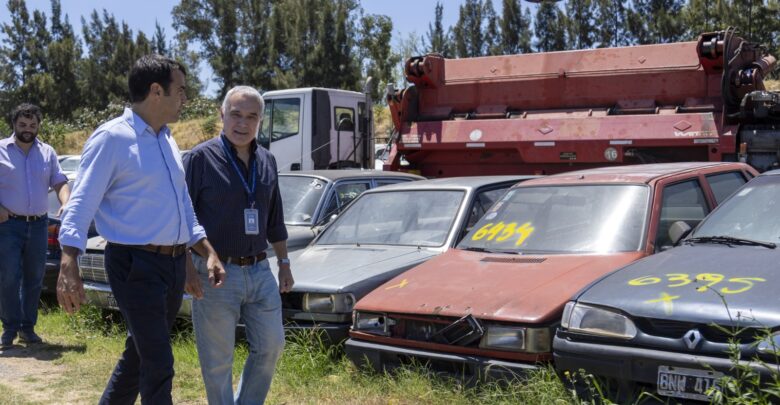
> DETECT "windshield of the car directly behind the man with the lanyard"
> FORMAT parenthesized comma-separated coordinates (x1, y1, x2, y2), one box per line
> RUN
(279, 176, 327, 225)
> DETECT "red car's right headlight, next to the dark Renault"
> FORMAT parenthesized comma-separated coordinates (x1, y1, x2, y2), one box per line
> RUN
(479, 325, 551, 353)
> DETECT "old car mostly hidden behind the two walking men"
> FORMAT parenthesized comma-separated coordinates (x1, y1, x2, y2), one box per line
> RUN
(79, 170, 423, 317)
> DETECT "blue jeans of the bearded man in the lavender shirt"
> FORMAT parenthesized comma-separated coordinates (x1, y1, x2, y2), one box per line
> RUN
(0, 217, 48, 333)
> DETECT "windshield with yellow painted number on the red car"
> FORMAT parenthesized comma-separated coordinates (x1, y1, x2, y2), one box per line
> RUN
(458, 185, 649, 254)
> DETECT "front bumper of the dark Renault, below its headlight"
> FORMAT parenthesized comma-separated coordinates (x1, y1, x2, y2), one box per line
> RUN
(553, 332, 780, 387)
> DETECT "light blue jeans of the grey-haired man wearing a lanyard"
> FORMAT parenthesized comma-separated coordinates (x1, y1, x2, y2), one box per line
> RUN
(192, 255, 284, 405)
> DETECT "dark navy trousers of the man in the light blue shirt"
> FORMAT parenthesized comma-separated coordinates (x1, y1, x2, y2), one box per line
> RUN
(100, 243, 185, 405)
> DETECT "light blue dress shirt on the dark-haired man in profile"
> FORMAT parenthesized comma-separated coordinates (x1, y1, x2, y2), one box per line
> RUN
(59, 108, 206, 252)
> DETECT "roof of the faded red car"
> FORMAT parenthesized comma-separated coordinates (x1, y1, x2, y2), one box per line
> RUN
(523, 162, 748, 186)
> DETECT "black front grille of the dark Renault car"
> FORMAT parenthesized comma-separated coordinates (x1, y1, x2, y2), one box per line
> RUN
(636, 318, 760, 344)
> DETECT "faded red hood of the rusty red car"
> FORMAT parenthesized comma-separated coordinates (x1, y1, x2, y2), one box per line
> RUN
(357, 249, 642, 323)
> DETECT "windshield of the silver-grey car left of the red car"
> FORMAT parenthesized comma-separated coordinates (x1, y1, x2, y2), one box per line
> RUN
(317, 190, 465, 247)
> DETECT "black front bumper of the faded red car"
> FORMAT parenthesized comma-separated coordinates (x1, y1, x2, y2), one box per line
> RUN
(344, 339, 539, 379)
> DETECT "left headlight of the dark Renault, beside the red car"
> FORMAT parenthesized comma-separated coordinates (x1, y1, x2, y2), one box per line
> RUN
(561, 301, 636, 339)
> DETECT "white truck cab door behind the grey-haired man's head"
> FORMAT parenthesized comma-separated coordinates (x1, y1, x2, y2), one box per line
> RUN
(258, 96, 305, 172)
